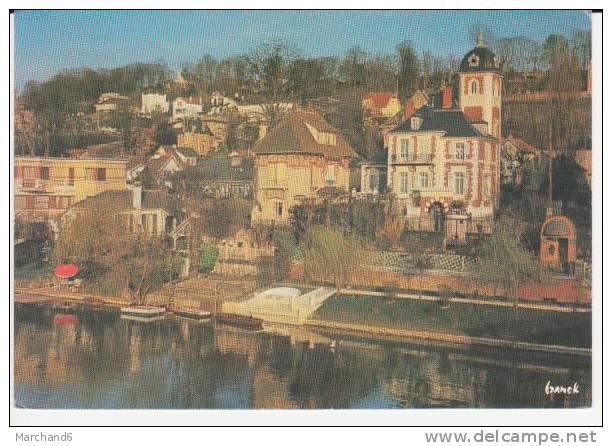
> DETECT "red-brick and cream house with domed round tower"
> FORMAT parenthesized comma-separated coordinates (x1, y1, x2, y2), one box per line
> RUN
(387, 36, 503, 243)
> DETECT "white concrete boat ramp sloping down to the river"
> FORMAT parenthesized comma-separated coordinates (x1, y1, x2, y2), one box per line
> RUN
(223, 287, 336, 325)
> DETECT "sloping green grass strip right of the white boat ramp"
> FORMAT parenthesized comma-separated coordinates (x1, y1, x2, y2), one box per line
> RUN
(313, 294, 591, 348)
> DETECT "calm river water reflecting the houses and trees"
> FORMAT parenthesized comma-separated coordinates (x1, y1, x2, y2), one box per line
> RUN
(14, 304, 591, 409)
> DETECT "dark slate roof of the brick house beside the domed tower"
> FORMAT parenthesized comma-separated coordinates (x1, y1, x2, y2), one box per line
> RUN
(389, 106, 496, 141)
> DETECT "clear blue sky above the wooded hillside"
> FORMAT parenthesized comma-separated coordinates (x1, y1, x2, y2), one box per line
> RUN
(15, 10, 590, 91)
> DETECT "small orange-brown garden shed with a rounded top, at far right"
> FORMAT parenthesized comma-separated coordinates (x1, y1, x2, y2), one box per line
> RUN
(540, 215, 576, 272)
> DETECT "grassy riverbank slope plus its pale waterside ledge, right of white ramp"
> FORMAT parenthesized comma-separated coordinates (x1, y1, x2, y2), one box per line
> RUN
(308, 294, 591, 353)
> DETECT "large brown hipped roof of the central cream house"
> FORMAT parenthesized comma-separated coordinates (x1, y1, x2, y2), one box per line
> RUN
(253, 111, 357, 159)
